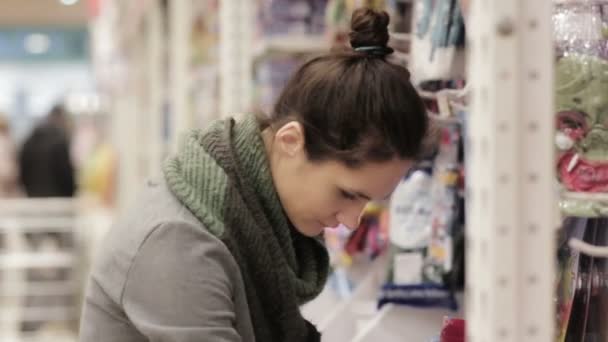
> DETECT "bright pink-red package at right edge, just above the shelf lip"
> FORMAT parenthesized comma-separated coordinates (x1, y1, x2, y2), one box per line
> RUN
(557, 152, 608, 192)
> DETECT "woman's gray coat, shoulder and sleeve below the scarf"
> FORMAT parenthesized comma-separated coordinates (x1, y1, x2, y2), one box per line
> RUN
(80, 182, 254, 342)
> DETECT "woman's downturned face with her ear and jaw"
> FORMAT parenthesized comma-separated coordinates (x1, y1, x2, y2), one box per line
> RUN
(264, 122, 412, 236)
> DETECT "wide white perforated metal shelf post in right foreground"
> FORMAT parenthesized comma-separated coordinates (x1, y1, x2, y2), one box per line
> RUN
(466, 0, 557, 342)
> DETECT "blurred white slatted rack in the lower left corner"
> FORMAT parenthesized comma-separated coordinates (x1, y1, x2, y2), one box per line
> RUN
(0, 199, 85, 341)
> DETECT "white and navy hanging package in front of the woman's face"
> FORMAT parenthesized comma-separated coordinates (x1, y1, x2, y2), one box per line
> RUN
(379, 124, 464, 310)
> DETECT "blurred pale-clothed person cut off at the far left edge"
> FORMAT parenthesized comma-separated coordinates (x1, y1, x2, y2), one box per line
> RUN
(0, 113, 18, 198)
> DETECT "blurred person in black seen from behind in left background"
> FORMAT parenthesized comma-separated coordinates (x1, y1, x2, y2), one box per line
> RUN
(19, 105, 76, 197)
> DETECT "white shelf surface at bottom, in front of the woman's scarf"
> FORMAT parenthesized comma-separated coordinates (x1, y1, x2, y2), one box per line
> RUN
(302, 255, 464, 342)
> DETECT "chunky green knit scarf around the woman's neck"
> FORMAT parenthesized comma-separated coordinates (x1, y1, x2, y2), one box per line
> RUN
(164, 117, 328, 342)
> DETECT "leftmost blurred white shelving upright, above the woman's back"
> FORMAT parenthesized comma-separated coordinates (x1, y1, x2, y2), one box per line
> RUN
(90, 0, 166, 208)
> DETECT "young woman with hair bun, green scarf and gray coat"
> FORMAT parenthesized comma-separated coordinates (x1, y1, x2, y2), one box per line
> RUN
(81, 9, 428, 342)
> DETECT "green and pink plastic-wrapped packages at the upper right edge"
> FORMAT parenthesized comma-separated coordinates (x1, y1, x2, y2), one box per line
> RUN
(553, 1, 608, 200)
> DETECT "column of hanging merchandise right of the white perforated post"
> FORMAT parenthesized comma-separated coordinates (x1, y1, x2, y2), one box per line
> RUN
(553, 5, 608, 342)
